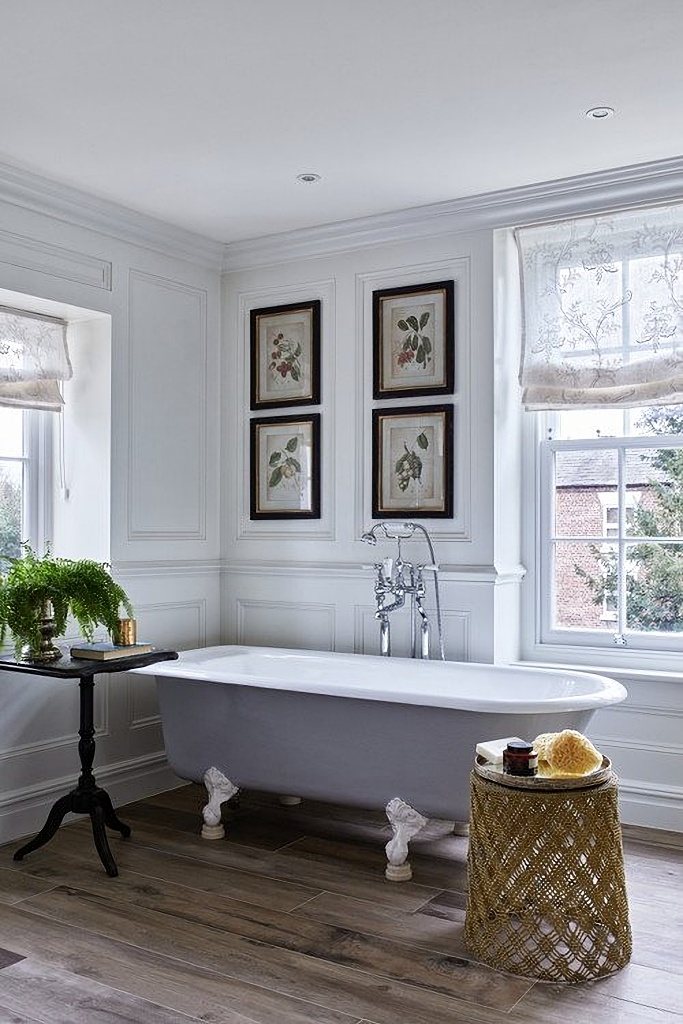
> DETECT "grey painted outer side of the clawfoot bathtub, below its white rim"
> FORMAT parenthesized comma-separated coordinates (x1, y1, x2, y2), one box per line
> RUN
(152, 676, 592, 822)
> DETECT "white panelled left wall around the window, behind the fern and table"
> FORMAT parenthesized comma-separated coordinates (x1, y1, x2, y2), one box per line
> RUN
(0, 169, 220, 842)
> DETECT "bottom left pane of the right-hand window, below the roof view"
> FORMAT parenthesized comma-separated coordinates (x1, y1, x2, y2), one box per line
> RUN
(552, 541, 616, 632)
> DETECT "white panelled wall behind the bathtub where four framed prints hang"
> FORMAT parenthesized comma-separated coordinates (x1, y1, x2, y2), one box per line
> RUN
(221, 165, 683, 830)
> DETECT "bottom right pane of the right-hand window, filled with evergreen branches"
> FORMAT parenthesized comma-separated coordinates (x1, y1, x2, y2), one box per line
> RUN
(627, 544, 683, 633)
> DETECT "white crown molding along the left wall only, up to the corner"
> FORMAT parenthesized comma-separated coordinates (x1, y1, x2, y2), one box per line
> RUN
(0, 155, 224, 269)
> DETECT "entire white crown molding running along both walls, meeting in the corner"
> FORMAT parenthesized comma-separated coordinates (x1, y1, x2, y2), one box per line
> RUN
(0, 149, 683, 272)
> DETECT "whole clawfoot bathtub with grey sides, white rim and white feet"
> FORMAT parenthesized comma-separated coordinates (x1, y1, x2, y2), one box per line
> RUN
(134, 646, 627, 880)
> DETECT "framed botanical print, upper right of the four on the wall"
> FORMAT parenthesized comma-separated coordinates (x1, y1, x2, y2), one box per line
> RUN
(373, 281, 455, 399)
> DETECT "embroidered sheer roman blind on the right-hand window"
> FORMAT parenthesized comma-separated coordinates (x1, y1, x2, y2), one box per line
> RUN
(515, 206, 683, 410)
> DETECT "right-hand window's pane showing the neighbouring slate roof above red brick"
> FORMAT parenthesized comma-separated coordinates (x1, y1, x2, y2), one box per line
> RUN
(555, 449, 618, 538)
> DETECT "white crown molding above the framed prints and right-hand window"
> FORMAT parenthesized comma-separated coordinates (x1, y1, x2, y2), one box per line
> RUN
(223, 157, 683, 272)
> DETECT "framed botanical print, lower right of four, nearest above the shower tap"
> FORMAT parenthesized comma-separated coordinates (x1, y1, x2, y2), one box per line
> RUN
(373, 406, 454, 519)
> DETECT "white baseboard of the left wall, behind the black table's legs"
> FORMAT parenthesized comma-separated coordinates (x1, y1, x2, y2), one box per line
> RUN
(0, 752, 185, 844)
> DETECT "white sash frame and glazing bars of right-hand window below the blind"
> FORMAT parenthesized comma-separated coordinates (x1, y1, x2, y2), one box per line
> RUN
(533, 414, 683, 653)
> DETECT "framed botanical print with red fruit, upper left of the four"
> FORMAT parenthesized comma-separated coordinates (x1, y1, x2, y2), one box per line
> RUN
(250, 299, 321, 409)
